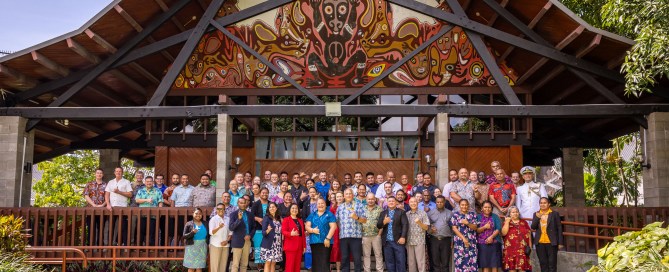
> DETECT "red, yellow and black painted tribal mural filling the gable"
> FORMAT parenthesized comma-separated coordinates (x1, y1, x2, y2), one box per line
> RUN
(174, 0, 516, 88)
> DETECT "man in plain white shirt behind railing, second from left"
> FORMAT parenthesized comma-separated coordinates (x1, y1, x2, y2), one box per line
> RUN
(105, 167, 132, 245)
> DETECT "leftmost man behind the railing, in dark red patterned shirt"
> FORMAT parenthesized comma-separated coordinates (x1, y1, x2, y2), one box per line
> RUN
(84, 168, 108, 245)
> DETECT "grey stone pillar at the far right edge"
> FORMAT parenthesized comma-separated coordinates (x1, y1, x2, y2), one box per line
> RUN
(643, 112, 669, 207)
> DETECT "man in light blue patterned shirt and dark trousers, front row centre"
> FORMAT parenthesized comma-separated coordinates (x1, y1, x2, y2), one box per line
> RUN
(337, 188, 367, 272)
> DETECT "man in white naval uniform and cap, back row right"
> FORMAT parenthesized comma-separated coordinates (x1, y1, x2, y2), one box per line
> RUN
(516, 166, 548, 221)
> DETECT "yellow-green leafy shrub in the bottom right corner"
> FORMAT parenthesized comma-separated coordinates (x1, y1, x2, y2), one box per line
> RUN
(588, 222, 669, 272)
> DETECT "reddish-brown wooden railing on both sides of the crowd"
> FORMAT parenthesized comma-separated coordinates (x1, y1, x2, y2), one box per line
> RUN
(0, 208, 669, 261)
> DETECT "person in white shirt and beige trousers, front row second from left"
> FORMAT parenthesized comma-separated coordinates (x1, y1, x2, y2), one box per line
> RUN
(209, 203, 232, 272)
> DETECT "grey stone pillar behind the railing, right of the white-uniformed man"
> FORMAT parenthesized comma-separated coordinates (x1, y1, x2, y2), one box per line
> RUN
(562, 147, 585, 207)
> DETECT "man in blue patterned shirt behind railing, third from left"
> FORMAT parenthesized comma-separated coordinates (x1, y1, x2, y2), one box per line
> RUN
(135, 176, 163, 246)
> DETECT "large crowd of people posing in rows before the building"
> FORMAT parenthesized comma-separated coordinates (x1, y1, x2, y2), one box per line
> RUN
(84, 162, 562, 272)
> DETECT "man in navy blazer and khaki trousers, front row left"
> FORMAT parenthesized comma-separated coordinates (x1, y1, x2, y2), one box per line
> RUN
(230, 198, 255, 272)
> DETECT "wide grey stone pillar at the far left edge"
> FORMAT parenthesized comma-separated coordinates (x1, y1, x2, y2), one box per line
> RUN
(0, 116, 34, 207)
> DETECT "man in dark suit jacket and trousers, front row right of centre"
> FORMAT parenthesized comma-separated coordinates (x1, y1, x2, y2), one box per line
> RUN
(376, 196, 409, 272)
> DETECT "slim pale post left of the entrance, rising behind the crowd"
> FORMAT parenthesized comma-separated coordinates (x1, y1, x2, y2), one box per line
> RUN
(216, 114, 232, 203)
